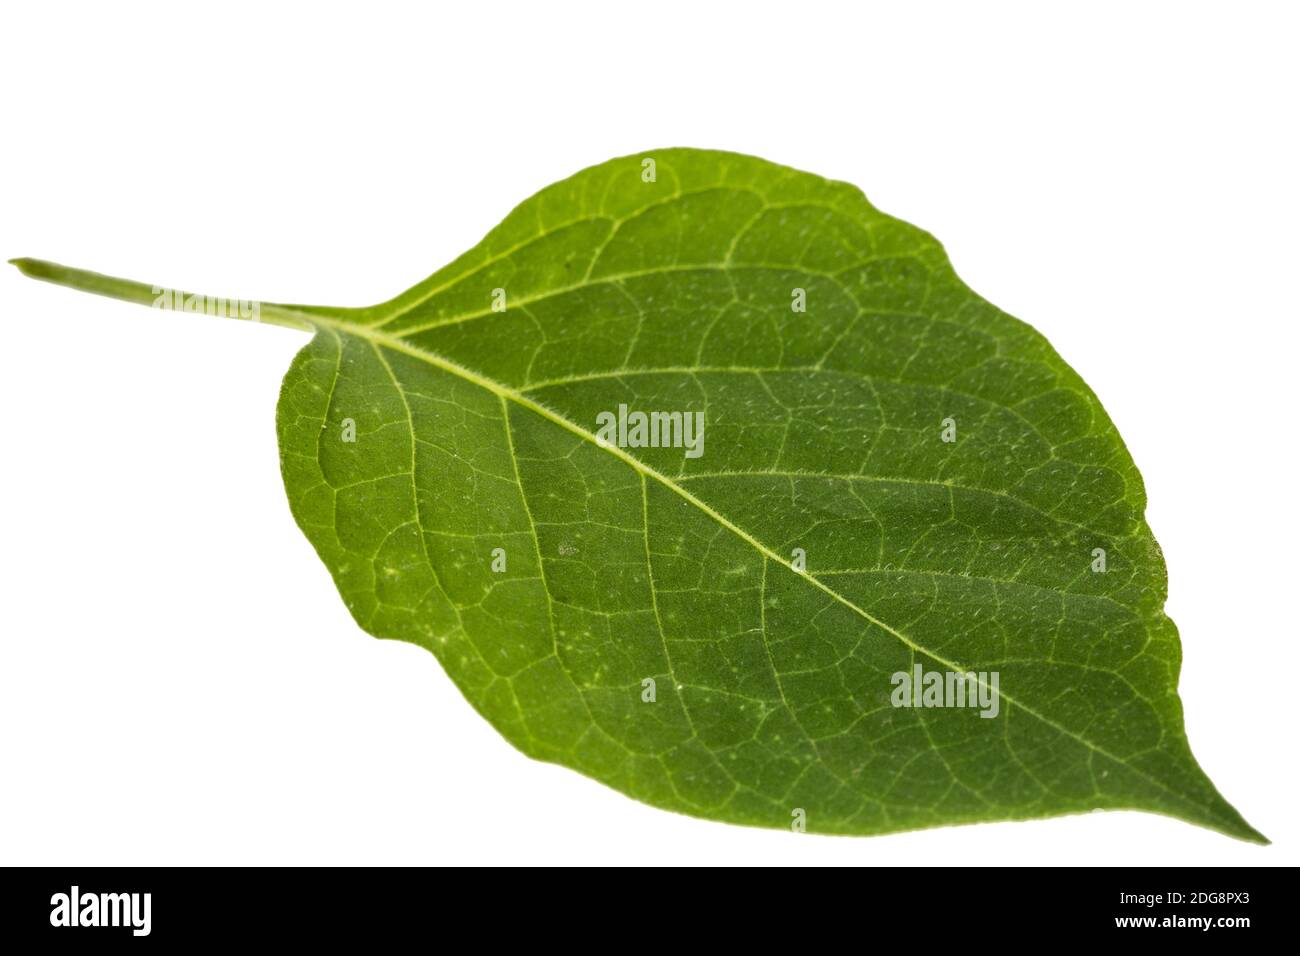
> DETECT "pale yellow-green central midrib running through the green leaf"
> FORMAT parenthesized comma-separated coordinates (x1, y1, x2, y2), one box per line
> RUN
(292, 306, 1209, 812)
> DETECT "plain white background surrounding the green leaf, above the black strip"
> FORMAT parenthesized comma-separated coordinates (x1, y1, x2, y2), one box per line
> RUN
(0, 0, 1300, 865)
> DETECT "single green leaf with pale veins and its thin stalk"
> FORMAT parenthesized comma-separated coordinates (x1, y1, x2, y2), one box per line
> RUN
(17, 150, 1264, 842)
